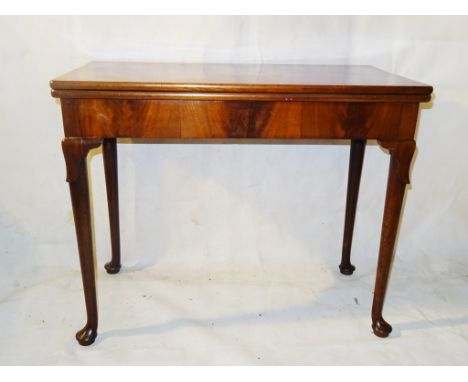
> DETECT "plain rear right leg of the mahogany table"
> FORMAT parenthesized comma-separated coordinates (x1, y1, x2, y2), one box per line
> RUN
(339, 139, 366, 275)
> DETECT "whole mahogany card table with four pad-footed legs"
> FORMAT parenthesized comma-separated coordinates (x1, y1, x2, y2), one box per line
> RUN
(50, 62, 432, 345)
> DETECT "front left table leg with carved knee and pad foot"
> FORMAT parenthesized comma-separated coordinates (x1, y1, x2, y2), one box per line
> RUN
(62, 138, 102, 345)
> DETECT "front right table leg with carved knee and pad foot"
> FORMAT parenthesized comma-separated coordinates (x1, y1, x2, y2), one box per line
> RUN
(372, 140, 416, 337)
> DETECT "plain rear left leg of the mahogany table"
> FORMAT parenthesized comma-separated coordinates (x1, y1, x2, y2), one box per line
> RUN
(102, 138, 121, 274)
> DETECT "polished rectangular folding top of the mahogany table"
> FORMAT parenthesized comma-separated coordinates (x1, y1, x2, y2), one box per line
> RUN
(50, 62, 432, 95)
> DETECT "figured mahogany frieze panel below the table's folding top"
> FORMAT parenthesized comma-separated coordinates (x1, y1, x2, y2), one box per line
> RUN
(61, 99, 419, 139)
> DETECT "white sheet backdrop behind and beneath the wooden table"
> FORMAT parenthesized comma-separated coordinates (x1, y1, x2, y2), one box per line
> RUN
(0, 16, 468, 365)
